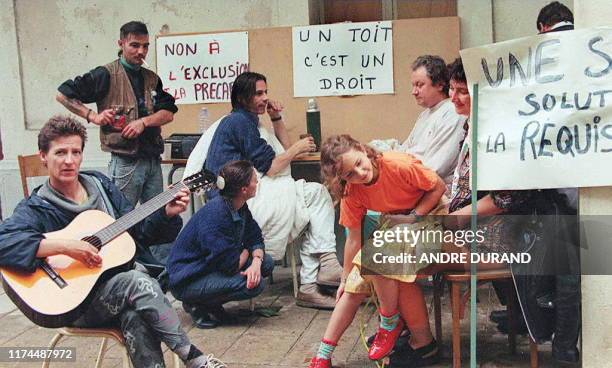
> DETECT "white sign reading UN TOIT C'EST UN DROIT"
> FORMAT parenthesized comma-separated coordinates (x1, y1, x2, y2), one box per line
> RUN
(293, 21, 394, 97)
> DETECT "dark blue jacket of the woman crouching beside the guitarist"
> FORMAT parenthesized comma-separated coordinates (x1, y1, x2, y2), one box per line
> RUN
(167, 195, 264, 289)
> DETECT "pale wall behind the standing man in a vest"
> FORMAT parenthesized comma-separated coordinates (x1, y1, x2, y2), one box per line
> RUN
(0, 0, 309, 217)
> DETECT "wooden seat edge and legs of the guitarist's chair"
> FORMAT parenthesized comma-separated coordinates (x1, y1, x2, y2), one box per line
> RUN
(42, 327, 181, 368)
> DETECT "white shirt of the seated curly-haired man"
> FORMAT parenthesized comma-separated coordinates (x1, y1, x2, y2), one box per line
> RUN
(399, 98, 465, 184)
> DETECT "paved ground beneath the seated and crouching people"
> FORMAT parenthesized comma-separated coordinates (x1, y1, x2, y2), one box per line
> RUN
(0, 266, 572, 368)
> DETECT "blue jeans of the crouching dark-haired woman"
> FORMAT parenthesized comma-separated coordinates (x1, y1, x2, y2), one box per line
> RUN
(171, 254, 274, 307)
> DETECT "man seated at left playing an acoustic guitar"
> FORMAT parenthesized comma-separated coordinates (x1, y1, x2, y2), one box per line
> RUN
(0, 116, 225, 368)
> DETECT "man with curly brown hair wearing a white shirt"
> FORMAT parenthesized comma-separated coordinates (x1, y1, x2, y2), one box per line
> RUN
(399, 55, 465, 187)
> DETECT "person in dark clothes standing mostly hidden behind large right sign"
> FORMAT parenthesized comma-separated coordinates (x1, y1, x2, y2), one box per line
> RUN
(502, 1, 581, 364)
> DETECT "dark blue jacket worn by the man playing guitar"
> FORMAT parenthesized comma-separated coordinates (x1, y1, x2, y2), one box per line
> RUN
(0, 171, 182, 272)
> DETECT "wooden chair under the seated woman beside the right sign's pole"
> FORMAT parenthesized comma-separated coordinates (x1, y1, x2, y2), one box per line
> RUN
(434, 270, 538, 368)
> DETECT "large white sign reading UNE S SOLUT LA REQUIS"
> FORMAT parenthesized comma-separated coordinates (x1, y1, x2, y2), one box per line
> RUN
(461, 28, 612, 190)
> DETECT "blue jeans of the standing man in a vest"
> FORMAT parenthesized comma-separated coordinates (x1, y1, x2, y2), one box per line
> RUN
(108, 154, 164, 207)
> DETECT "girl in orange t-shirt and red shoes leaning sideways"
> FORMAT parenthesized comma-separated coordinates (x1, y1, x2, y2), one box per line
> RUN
(310, 135, 446, 368)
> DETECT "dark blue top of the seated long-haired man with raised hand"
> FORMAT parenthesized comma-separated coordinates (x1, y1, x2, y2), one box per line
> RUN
(204, 109, 276, 174)
